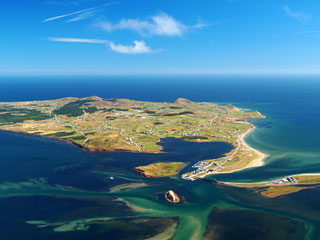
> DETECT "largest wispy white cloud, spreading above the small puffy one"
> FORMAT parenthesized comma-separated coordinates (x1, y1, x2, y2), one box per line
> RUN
(98, 13, 212, 36)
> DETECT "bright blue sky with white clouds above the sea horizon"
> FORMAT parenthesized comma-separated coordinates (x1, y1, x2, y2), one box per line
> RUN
(0, 0, 320, 75)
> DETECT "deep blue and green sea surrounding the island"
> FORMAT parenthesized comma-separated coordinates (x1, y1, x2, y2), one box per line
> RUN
(0, 75, 320, 240)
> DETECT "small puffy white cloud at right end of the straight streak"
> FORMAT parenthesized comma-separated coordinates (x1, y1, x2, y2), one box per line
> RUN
(109, 41, 155, 54)
